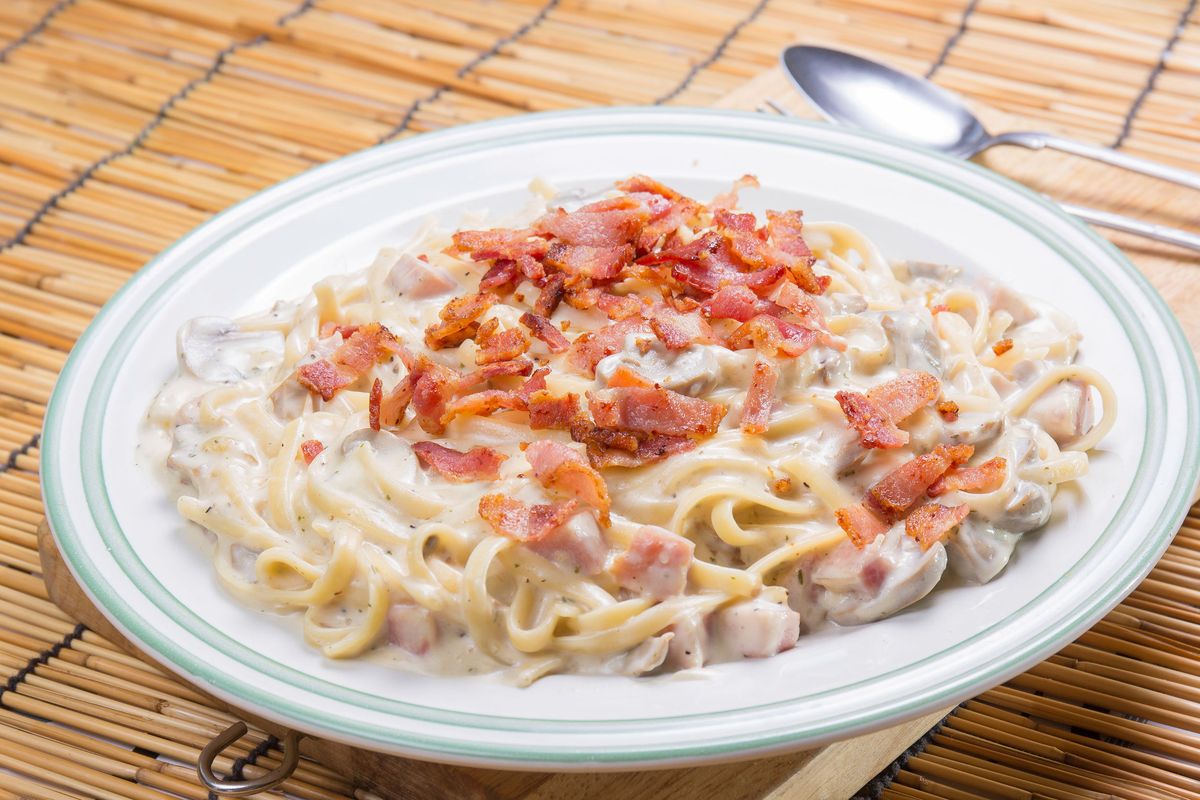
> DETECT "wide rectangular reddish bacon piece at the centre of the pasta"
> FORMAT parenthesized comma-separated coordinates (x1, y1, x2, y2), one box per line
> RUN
(588, 386, 727, 437)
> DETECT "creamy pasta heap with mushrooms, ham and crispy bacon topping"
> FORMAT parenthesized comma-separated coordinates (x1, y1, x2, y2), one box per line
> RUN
(143, 175, 1116, 685)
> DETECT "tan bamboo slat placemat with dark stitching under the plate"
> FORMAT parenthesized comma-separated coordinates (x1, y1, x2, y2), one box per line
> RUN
(0, 0, 1200, 800)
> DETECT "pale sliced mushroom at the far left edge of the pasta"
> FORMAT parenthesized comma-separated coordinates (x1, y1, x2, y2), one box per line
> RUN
(176, 317, 283, 384)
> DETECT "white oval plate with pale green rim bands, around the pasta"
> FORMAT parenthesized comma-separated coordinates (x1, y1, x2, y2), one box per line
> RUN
(42, 109, 1200, 770)
